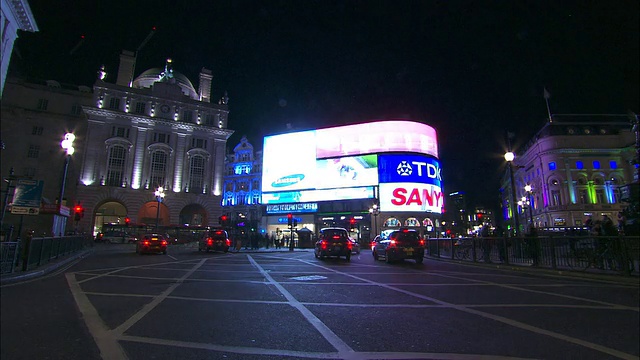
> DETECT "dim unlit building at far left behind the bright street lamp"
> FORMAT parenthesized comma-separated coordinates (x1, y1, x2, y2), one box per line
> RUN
(0, 77, 93, 238)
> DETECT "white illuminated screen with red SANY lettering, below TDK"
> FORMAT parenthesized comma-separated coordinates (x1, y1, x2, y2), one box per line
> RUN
(379, 183, 444, 214)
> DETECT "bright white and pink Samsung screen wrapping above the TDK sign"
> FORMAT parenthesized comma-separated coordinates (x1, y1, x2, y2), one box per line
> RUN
(262, 120, 439, 204)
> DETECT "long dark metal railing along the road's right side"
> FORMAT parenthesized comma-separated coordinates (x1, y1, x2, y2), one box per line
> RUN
(427, 236, 640, 275)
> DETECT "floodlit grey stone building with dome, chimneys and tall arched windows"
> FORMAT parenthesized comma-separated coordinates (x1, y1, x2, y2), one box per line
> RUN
(77, 51, 233, 233)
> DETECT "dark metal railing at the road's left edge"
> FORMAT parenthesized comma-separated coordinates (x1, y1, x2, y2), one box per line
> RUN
(0, 236, 90, 274)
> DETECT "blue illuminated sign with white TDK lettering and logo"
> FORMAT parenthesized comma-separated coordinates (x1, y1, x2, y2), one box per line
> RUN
(378, 154, 442, 187)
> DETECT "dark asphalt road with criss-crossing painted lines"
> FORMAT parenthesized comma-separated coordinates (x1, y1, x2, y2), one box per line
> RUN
(0, 244, 640, 360)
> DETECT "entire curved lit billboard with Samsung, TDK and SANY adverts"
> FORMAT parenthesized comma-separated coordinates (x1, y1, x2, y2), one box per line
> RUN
(262, 120, 443, 213)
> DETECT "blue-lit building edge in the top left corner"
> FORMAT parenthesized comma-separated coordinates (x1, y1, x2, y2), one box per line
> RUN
(0, 0, 38, 98)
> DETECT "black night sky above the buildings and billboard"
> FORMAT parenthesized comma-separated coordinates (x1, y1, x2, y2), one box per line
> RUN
(11, 0, 640, 211)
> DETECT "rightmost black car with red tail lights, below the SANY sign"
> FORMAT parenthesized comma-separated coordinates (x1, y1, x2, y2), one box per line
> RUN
(373, 229, 424, 264)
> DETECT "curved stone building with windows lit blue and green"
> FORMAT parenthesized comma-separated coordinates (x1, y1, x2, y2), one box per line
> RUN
(500, 115, 635, 233)
